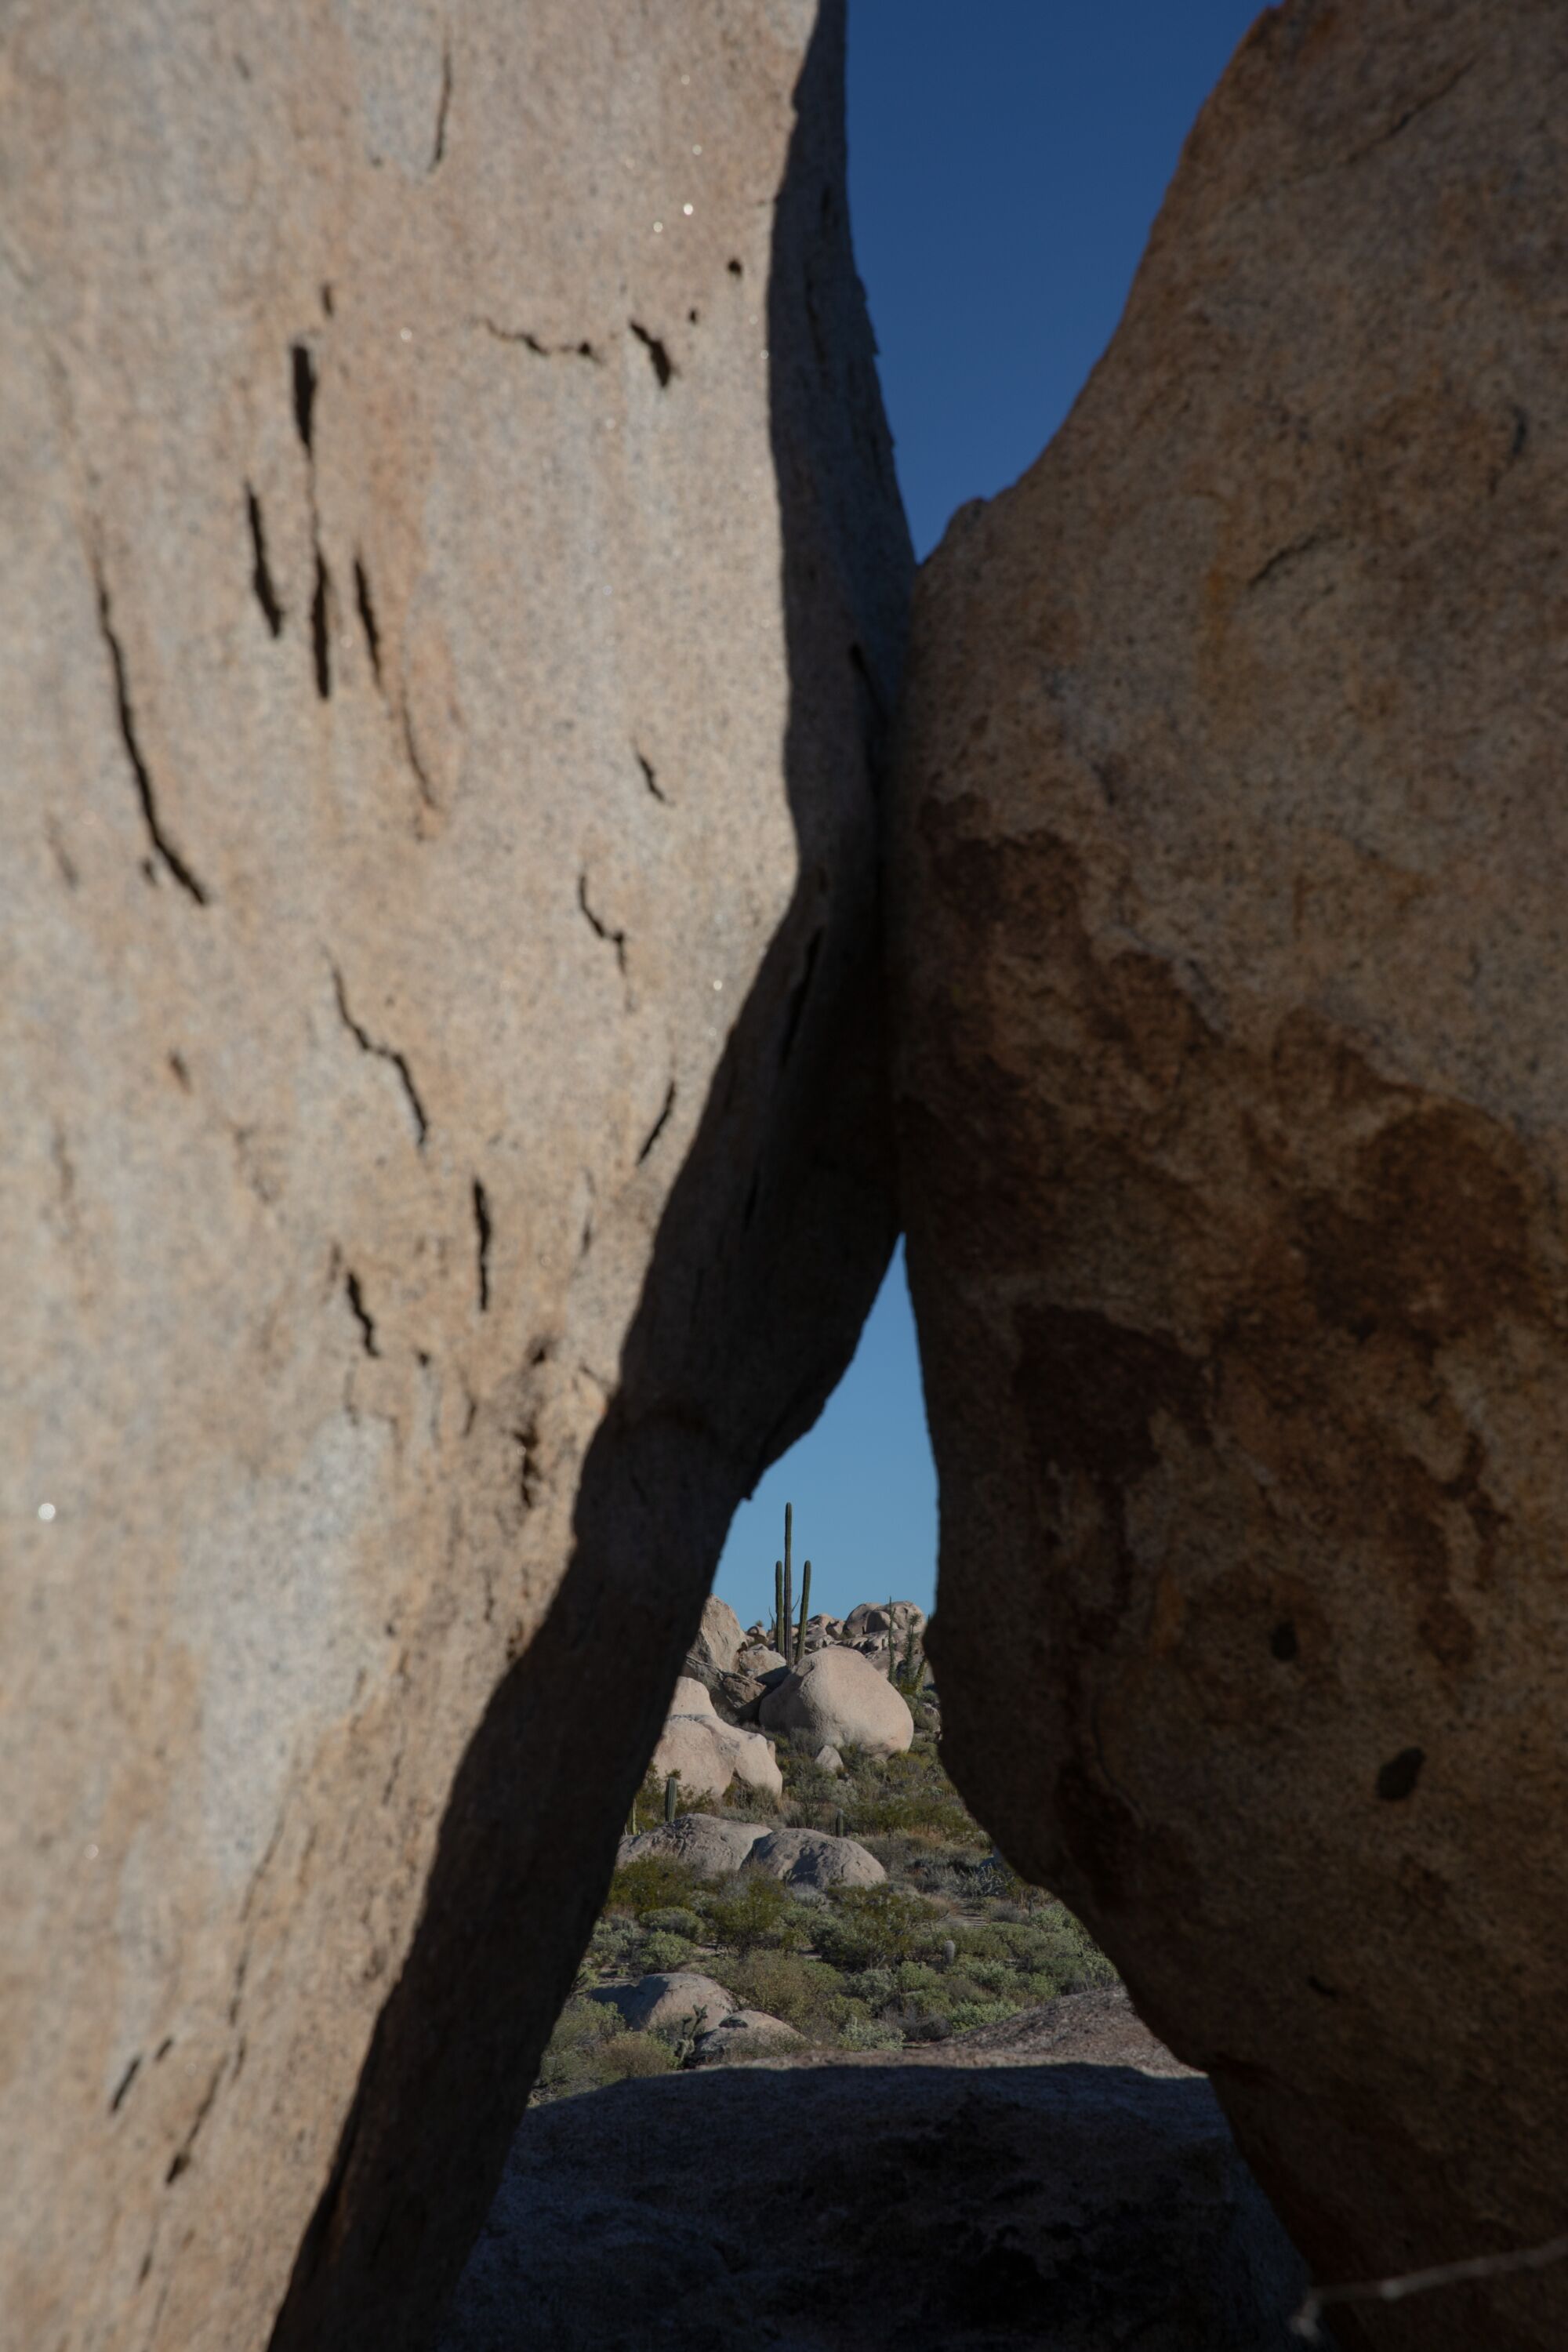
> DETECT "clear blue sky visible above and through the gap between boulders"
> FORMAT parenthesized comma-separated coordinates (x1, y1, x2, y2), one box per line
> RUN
(715, 0, 1258, 1625)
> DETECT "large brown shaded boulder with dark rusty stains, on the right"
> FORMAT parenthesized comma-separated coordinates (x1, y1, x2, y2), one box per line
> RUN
(895, 0, 1568, 2352)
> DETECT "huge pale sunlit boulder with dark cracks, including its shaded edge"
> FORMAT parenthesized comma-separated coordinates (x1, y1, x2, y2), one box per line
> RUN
(0, 0, 907, 2352)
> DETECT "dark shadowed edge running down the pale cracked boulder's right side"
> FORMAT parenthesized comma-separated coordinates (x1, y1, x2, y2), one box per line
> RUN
(270, 0, 912, 2352)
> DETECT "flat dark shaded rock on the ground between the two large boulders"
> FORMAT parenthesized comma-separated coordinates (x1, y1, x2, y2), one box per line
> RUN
(440, 2065, 1302, 2352)
